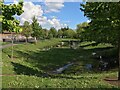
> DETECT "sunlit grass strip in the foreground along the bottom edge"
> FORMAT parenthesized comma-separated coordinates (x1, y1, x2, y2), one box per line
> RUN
(3, 73, 115, 88)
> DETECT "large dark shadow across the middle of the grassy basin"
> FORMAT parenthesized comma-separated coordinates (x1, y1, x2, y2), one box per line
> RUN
(16, 48, 83, 71)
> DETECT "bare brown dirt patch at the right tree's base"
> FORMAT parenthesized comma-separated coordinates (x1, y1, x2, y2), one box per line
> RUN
(104, 77, 120, 88)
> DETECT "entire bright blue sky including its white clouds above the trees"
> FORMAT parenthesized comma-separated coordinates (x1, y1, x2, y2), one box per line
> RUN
(4, 0, 89, 29)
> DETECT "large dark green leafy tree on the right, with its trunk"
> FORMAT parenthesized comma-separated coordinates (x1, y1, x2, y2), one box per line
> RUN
(81, 2, 120, 80)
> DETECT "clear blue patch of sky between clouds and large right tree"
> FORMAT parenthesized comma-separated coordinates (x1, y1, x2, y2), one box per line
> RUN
(45, 2, 88, 28)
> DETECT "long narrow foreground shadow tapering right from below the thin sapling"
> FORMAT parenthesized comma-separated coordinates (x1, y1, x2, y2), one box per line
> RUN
(11, 62, 96, 79)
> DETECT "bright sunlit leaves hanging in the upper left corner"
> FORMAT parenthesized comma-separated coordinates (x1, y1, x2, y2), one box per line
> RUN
(2, 2, 23, 32)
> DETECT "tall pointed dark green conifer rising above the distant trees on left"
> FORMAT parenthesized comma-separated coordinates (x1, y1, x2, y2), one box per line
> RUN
(31, 17, 42, 43)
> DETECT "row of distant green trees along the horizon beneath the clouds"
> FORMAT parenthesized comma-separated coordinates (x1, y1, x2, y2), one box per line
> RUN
(21, 17, 88, 39)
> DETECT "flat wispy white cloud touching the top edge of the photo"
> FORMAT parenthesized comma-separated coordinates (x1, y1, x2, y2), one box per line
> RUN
(45, 0, 64, 13)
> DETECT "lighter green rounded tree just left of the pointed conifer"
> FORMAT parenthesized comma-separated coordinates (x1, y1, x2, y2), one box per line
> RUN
(22, 21, 32, 43)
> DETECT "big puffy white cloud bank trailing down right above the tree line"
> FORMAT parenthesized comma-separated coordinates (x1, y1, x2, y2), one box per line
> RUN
(20, 2, 67, 29)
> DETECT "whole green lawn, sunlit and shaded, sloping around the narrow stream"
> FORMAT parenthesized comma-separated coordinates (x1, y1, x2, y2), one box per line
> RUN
(2, 39, 117, 89)
